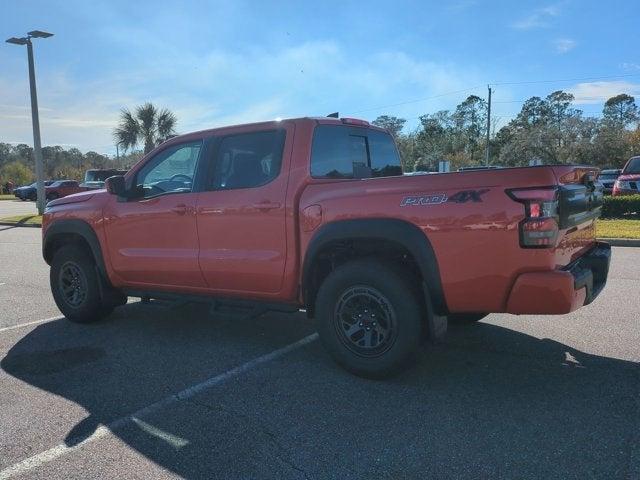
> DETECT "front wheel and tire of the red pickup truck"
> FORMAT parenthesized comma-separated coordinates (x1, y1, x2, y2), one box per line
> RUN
(49, 245, 114, 323)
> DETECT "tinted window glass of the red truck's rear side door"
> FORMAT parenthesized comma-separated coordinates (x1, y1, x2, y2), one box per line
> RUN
(209, 130, 285, 190)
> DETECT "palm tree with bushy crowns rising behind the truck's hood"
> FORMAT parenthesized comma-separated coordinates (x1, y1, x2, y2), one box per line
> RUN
(113, 102, 178, 154)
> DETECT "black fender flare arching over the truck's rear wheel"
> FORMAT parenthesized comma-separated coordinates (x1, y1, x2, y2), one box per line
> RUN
(302, 218, 448, 315)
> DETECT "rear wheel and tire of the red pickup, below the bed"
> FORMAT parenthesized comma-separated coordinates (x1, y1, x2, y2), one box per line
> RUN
(315, 259, 425, 378)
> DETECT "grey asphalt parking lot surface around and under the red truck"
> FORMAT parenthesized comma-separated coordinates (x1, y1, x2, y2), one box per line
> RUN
(0, 226, 640, 480)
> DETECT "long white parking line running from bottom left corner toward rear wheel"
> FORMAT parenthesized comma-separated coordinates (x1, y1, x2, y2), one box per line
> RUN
(0, 333, 318, 480)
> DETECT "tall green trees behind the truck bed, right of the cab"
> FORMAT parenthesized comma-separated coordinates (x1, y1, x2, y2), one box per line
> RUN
(373, 90, 640, 171)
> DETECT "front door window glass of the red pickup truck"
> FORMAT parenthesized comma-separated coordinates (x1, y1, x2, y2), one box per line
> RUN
(136, 141, 202, 198)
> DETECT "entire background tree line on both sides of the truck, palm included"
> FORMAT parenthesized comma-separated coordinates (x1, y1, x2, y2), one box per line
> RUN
(0, 90, 640, 185)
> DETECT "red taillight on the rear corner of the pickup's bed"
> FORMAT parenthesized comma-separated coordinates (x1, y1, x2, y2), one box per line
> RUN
(507, 187, 558, 248)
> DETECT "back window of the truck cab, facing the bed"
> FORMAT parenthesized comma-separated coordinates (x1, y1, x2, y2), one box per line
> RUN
(311, 125, 402, 178)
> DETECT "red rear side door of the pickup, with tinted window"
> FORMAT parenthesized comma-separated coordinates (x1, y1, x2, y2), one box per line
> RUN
(196, 124, 295, 296)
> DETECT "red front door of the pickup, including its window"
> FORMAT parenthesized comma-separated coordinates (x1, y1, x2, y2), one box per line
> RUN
(104, 140, 205, 290)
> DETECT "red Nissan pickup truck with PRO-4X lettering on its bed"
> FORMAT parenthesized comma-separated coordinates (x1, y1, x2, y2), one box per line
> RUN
(43, 118, 611, 377)
